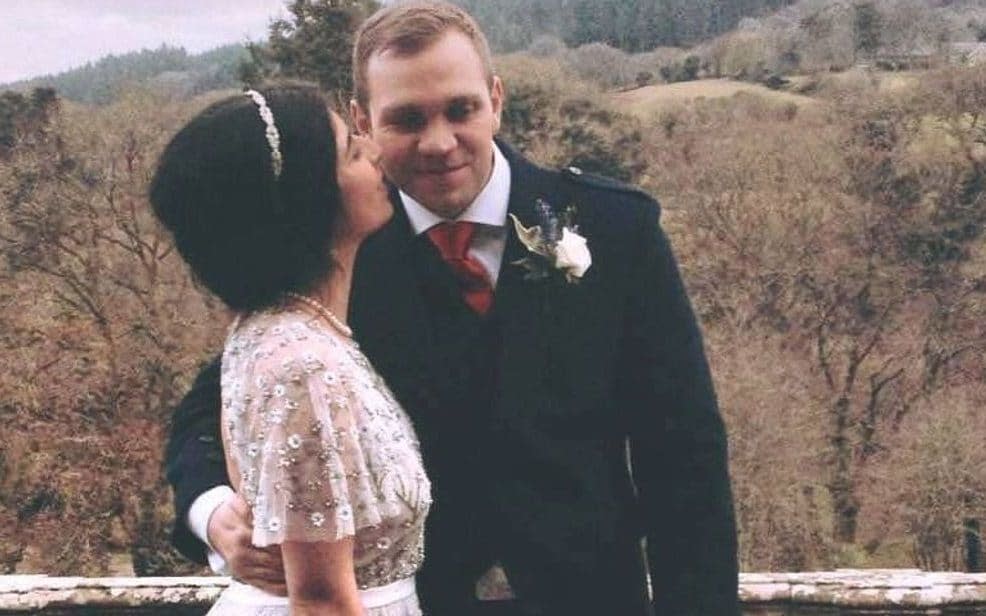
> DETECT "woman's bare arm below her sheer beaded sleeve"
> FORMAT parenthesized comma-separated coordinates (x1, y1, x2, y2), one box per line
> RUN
(281, 536, 363, 616)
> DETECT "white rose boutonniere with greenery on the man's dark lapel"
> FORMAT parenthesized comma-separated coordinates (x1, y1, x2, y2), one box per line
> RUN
(510, 199, 592, 283)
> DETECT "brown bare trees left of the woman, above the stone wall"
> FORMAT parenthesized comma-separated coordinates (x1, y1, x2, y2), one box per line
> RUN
(0, 93, 227, 574)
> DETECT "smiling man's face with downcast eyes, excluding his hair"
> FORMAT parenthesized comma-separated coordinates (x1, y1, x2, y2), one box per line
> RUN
(352, 30, 503, 218)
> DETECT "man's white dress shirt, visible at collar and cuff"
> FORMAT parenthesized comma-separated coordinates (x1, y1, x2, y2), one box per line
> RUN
(187, 143, 511, 575)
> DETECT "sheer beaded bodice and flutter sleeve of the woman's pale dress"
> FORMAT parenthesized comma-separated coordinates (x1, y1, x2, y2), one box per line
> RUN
(228, 313, 428, 588)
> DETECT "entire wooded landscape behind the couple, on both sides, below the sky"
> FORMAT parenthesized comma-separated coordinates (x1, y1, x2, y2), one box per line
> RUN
(0, 0, 986, 575)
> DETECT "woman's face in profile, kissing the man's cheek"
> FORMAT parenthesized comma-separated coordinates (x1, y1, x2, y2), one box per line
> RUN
(330, 111, 394, 236)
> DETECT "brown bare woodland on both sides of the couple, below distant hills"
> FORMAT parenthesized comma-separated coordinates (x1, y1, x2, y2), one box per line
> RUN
(0, 57, 986, 574)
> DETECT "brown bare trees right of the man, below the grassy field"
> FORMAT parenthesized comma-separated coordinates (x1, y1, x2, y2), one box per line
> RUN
(651, 69, 986, 567)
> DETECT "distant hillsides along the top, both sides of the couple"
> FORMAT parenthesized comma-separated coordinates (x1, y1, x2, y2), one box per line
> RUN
(7, 0, 986, 105)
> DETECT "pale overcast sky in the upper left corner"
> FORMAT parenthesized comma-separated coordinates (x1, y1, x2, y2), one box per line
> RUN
(0, 0, 286, 83)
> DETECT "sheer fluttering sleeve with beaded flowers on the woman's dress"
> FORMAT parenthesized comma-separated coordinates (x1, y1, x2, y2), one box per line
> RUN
(231, 345, 379, 547)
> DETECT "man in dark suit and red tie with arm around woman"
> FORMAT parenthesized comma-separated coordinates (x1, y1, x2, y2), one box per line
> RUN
(167, 2, 738, 616)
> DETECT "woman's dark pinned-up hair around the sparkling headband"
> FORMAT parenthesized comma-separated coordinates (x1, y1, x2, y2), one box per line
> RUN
(150, 83, 340, 311)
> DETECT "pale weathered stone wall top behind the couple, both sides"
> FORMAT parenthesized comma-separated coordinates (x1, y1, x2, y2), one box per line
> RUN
(0, 569, 986, 616)
